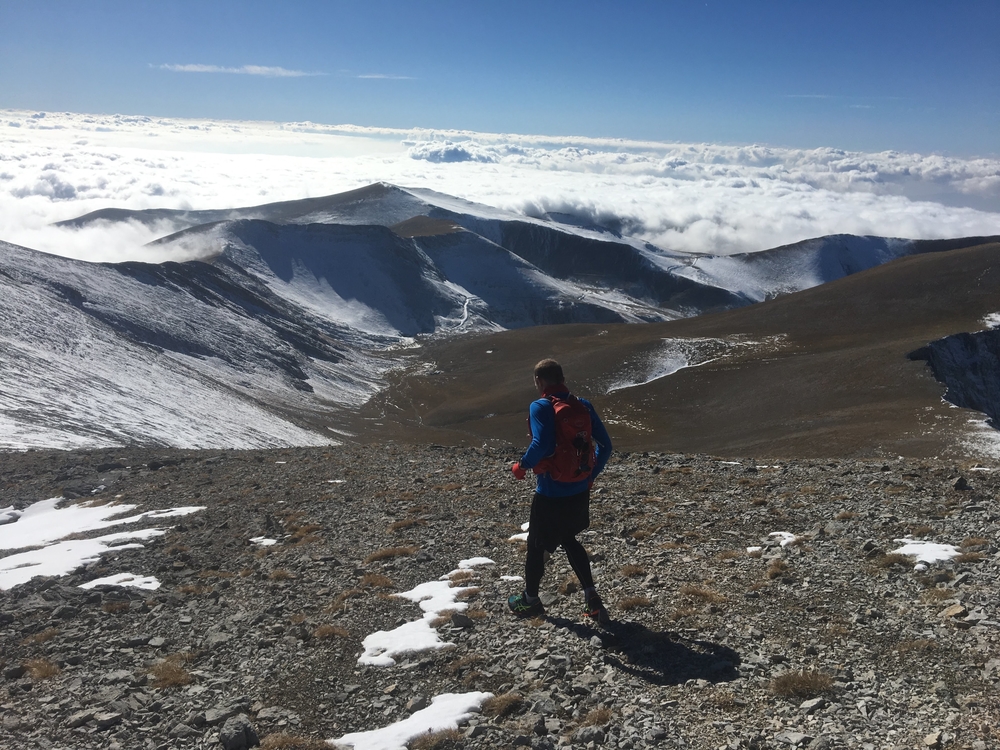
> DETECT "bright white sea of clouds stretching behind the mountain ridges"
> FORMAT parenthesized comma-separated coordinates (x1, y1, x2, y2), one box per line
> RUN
(0, 110, 1000, 261)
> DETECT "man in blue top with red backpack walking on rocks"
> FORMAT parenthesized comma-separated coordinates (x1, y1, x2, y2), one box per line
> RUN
(507, 359, 611, 624)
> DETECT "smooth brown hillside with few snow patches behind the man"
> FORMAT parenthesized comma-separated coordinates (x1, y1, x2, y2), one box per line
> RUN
(363, 243, 1000, 457)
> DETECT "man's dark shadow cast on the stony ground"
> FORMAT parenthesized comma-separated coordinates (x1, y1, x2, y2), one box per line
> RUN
(548, 617, 740, 685)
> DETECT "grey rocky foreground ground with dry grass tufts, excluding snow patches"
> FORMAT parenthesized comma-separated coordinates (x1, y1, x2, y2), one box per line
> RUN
(0, 444, 1000, 750)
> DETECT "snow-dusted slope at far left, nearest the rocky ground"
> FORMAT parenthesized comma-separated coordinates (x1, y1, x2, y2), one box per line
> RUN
(0, 243, 388, 448)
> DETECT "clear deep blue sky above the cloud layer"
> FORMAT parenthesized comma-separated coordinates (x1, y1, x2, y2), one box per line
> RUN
(0, 0, 1000, 156)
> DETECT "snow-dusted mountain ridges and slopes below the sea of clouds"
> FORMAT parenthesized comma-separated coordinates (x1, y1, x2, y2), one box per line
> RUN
(0, 184, 988, 448)
